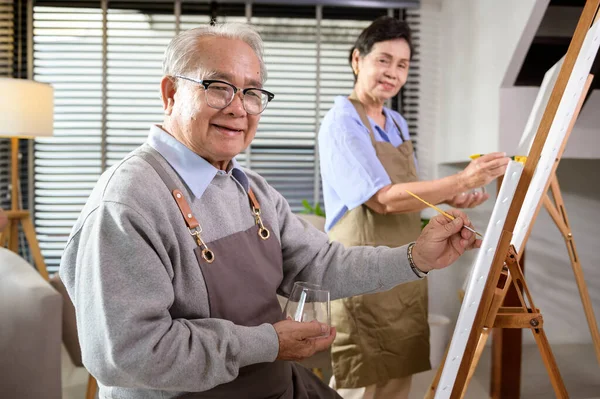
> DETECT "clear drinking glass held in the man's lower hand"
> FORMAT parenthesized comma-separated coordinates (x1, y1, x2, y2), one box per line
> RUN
(283, 281, 331, 337)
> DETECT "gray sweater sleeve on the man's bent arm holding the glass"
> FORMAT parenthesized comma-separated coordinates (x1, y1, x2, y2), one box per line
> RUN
(60, 201, 279, 392)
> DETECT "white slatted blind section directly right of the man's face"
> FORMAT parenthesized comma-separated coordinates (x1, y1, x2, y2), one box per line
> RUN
(251, 17, 317, 211)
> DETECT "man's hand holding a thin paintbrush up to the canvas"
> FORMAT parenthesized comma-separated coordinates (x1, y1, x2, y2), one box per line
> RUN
(413, 209, 481, 272)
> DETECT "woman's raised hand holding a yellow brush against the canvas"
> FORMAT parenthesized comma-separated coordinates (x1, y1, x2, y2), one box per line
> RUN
(459, 152, 510, 190)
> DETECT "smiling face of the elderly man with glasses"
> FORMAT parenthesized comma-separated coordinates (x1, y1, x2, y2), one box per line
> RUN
(163, 37, 262, 169)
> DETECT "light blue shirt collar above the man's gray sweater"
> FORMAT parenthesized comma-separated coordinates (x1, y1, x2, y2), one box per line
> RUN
(148, 125, 249, 198)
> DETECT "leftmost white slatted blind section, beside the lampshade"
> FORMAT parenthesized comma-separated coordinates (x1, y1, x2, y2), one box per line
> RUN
(34, 2, 102, 269)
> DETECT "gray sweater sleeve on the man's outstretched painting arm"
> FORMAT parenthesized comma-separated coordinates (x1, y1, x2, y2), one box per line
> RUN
(271, 189, 419, 299)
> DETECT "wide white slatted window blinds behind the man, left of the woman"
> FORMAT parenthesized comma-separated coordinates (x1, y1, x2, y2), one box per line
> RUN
(31, 0, 414, 270)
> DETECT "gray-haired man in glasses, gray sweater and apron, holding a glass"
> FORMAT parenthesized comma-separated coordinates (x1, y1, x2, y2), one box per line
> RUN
(60, 24, 480, 399)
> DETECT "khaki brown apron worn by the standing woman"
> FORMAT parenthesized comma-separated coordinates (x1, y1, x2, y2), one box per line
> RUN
(329, 93, 431, 388)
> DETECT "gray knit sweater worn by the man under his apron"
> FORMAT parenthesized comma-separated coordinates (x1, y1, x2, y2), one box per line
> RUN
(60, 144, 417, 399)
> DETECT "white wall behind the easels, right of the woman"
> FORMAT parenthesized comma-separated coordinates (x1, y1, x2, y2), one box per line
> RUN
(419, 0, 600, 344)
